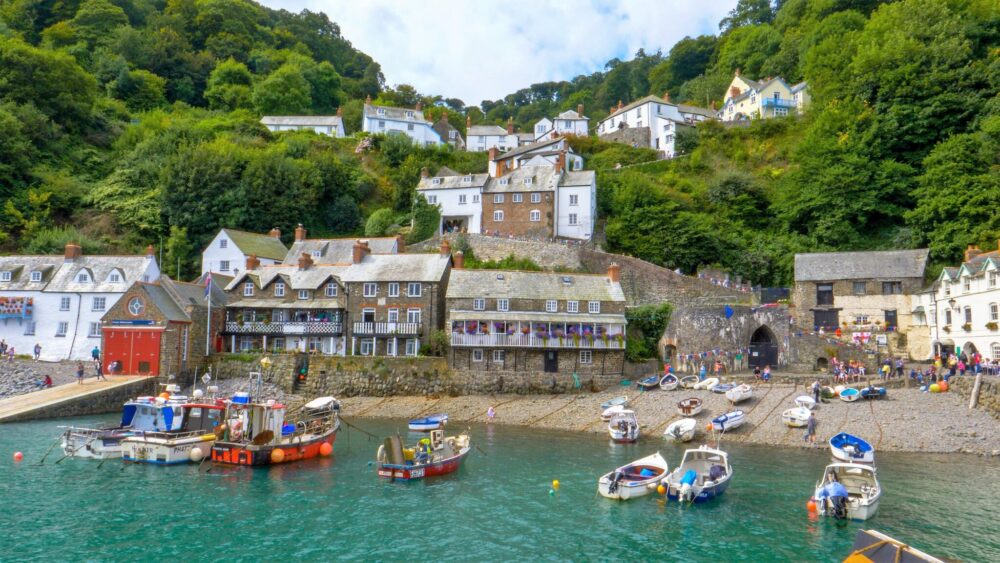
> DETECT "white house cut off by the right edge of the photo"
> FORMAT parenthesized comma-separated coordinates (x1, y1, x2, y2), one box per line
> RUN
(920, 241, 1000, 359)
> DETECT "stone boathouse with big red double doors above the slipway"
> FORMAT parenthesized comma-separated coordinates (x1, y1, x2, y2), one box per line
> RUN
(101, 276, 226, 376)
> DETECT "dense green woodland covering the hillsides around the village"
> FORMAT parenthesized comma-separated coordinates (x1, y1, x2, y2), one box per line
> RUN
(0, 0, 1000, 284)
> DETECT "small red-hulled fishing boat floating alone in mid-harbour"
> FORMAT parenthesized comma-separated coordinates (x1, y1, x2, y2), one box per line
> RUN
(376, 430, 472, 481)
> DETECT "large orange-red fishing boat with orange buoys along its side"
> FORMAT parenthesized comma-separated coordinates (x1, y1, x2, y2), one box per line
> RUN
(212, 393, 340, 465)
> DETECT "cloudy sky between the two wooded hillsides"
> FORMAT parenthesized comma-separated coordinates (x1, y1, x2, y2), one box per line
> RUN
(263, 0, 736, 105)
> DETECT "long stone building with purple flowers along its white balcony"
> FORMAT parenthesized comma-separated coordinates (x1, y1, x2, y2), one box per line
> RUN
(447, 258, 626, 375)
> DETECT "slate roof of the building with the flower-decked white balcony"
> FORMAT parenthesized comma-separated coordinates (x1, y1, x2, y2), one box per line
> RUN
(447, 269, 625, 304)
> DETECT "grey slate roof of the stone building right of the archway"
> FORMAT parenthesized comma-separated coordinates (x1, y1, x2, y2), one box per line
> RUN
(795, 248, 930, 281)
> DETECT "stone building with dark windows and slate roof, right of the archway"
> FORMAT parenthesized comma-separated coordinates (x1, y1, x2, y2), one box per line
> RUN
(792, 249, 928, 356)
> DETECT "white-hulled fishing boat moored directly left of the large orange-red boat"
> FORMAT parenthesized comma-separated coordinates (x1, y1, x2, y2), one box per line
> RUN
(121, 401, 226, 465)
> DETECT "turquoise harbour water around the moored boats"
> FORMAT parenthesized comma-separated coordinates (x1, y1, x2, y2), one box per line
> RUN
(0, 418, 1000, 561)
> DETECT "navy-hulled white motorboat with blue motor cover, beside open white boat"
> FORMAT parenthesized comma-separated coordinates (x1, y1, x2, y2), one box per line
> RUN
(662, 446, 733, 503)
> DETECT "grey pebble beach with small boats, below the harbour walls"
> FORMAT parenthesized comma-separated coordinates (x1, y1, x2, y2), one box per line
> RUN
(334, 384, 1000, 456)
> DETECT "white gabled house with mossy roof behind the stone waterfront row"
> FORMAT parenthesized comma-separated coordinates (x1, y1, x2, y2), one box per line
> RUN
(201, 225, 288, 276)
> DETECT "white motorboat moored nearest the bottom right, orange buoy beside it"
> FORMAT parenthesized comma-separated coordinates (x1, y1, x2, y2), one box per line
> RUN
(813, 463, 882, 520)
